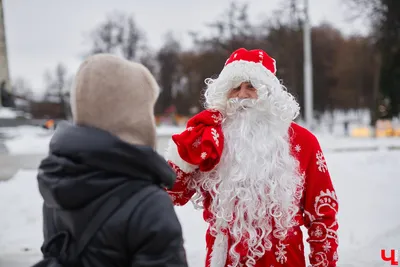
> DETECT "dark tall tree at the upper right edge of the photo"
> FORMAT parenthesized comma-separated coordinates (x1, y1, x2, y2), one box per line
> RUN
(348, 0, 400, 119)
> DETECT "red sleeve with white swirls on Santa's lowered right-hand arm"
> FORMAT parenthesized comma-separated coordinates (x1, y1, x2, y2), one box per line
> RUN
(304, 135, 339, 267)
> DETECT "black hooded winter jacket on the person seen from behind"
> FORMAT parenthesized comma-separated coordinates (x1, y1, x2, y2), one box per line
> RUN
(38, 122, 187, 267)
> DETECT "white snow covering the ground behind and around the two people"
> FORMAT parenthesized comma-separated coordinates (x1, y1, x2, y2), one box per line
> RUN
(0, 127, 400, 267)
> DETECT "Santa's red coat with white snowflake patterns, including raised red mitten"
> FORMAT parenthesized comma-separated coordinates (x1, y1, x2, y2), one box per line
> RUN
(167, 111, 338, 267)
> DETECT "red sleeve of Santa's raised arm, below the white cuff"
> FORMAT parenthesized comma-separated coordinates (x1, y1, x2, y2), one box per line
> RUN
(167, 161, 196, 206)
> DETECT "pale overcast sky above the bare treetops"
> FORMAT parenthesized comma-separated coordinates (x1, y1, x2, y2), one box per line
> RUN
(3, 0, 367, 91)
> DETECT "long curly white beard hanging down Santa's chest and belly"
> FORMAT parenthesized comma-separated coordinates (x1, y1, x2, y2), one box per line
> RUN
(191, 100, 303, 266)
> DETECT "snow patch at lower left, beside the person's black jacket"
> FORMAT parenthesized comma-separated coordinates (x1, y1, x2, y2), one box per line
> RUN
(0, 171, 42, 267)
